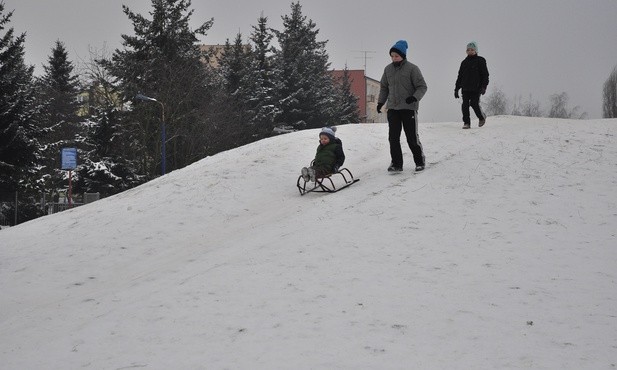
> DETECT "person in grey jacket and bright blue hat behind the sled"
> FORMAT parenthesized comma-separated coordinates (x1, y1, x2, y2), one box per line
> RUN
(377, 40, 427, 171)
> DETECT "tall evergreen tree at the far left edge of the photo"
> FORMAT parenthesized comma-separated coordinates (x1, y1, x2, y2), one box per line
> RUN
(0, 1, 41, 222)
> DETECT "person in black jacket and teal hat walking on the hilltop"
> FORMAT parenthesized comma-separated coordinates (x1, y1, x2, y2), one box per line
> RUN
(454, 41, 488, 129)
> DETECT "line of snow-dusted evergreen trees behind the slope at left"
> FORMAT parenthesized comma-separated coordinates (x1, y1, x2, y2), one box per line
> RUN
(0, 0, 360, 224)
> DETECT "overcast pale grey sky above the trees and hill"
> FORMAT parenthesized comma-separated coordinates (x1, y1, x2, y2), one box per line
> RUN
(0, 0, 617, 122)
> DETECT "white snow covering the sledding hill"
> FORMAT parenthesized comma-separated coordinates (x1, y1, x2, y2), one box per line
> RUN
(0, 116, 617, 369)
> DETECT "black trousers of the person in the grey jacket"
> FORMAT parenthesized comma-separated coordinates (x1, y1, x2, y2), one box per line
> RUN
(388, 109, 424, 168)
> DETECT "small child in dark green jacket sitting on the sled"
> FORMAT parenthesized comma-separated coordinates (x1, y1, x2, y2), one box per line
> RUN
(301, 126, 345, 182)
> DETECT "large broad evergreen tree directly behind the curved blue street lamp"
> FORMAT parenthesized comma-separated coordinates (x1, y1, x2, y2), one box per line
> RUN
(105, 0, 215, 178)
